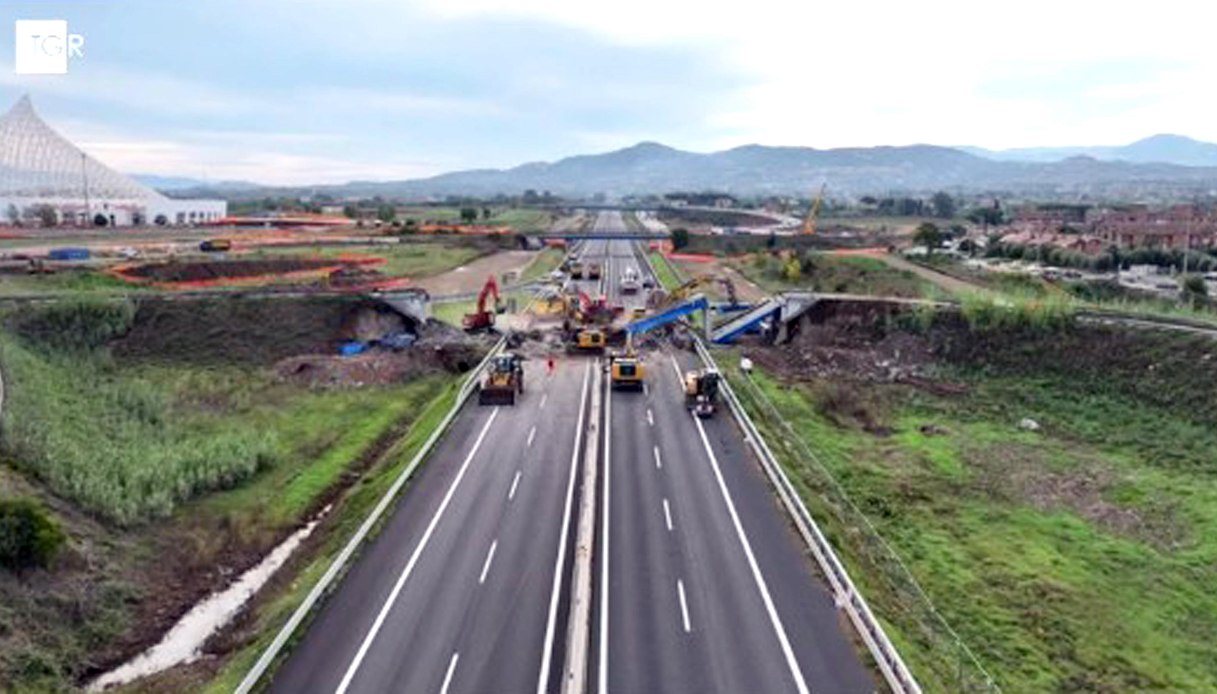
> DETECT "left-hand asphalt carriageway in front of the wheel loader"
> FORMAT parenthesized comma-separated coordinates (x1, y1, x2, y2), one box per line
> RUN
(273, 359, 593, 693)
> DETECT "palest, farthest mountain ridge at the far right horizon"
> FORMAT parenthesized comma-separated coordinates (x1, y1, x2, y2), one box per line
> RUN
(959, 135, 1217, 167)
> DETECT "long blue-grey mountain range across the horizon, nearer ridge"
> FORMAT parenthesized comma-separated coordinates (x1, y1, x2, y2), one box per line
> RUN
(276, 139, 1217, 198)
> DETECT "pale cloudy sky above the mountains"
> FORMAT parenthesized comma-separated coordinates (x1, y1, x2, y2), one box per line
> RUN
(0, 0, 1217, 184)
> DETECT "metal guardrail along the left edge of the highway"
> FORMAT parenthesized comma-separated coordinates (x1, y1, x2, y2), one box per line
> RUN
(235, 337, 506, 694)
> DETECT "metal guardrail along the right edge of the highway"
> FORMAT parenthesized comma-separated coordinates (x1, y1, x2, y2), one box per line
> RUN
(694, 338, 921, 694)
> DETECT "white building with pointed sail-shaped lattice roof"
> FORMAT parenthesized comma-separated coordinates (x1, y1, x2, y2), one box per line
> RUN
(0, 96, 228, 226)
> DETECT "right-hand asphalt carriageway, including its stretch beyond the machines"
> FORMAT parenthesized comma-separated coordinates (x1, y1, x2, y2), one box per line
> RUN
(585, 212, 876, 694)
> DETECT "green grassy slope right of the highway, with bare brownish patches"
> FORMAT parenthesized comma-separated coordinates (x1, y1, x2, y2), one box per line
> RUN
(730, 317, 1217, 692)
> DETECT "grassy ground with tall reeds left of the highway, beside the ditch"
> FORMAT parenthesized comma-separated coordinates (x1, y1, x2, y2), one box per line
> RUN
(0, 295, 455, 690)
